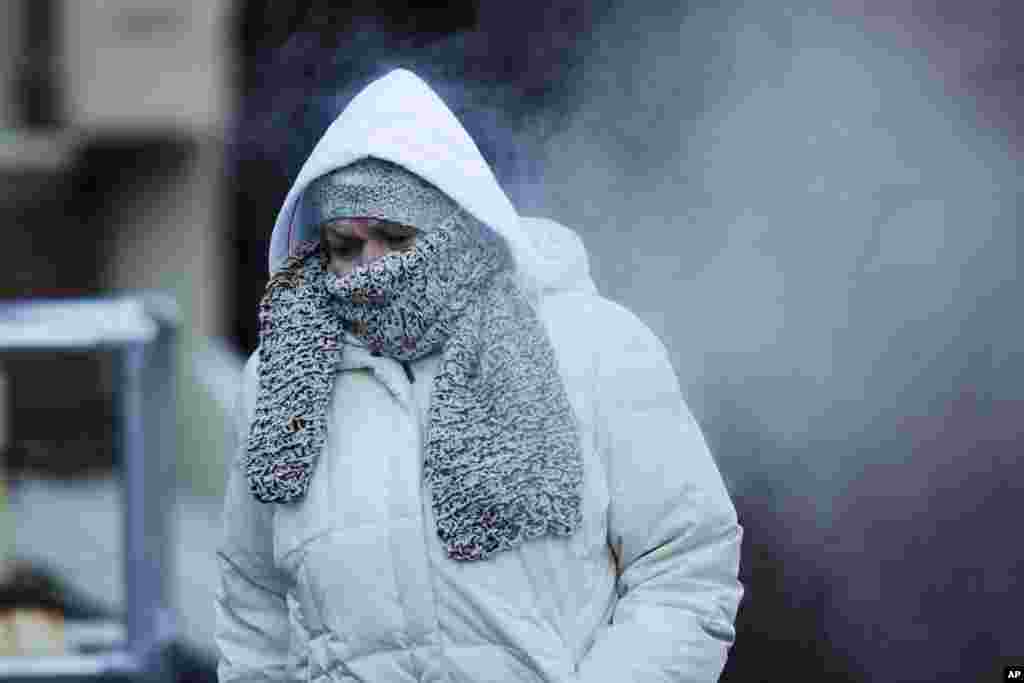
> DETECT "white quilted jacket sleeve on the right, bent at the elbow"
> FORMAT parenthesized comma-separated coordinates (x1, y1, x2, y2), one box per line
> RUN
(579, 302, 743, 683)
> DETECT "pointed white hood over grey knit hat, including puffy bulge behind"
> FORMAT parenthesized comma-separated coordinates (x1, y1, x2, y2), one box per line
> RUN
(269, 69, 593, 296)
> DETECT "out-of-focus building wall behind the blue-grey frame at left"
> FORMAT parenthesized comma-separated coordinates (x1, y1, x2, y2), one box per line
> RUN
(0, 0, 234, 494)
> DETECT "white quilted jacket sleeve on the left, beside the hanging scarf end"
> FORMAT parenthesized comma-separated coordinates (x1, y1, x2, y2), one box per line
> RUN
(214, 354, 294, 683)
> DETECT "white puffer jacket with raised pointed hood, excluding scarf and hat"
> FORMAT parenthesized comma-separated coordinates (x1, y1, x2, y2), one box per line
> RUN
(216, 71, 743, 683)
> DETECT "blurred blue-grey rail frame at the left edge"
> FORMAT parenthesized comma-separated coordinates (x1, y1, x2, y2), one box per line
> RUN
(0, 292, 180, 683)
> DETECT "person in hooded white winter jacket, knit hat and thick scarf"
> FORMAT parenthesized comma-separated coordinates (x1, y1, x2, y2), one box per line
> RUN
(216, 70, 743, 683)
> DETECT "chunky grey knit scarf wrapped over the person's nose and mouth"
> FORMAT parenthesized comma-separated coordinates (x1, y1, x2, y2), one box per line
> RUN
(246, 158, 583, 560)
